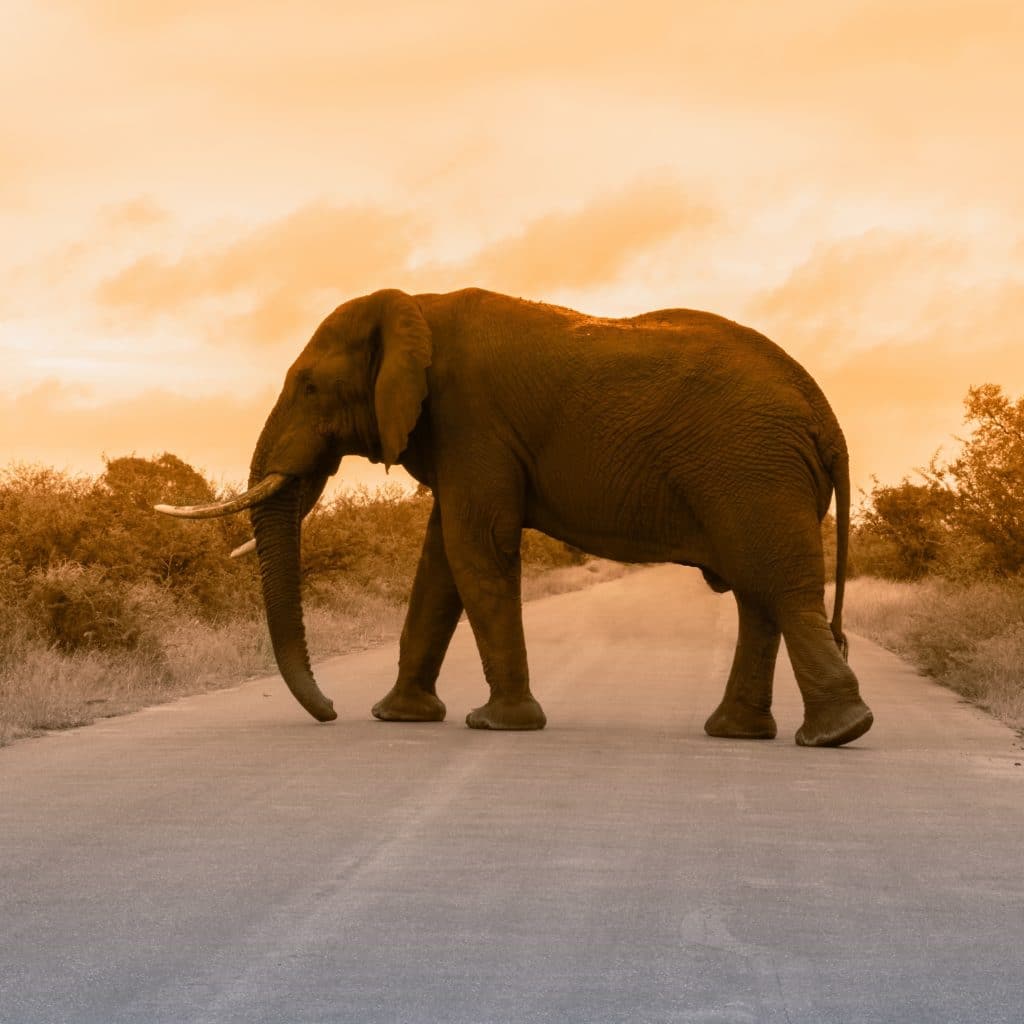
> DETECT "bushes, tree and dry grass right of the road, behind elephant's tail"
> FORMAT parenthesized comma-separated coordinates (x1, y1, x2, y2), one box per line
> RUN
(846, 384, 1024, 729)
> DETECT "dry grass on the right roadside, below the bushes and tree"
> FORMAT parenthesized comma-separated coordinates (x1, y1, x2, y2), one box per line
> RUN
(845, 577, 1024, 729)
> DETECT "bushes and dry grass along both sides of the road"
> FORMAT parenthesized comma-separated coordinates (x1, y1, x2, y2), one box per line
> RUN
(0, 385, 1024, 745)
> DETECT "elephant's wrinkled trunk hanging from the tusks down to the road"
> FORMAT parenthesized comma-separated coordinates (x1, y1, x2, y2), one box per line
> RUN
(251, 480, 338, 722)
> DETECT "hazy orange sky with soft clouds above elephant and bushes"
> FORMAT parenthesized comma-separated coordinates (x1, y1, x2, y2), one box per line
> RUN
(0, 0, 1024, 499)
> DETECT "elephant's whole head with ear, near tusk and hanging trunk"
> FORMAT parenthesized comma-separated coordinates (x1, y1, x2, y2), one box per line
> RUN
(157, 290, 431, 722)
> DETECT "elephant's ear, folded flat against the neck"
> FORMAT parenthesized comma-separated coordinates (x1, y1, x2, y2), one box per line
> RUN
(374, 289, 433, 467)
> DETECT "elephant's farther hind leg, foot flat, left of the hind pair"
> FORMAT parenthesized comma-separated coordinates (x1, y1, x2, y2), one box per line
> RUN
(705, 594, 781, 739)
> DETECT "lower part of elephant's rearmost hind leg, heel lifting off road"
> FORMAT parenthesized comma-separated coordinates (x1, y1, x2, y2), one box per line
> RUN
(782, 608, 874, 746)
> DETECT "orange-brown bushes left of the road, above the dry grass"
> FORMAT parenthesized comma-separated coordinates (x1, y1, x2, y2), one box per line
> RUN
(0, 453, 584, 656)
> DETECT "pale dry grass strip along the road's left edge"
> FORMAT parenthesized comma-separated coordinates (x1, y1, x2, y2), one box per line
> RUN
(0, 560, 629, 746)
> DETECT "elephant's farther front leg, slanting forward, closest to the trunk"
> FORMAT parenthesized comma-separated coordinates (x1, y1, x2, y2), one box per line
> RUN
(373, 501, 462, 722)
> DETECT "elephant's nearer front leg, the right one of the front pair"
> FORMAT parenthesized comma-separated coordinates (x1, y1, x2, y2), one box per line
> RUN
(444, 499, 548, 729)
